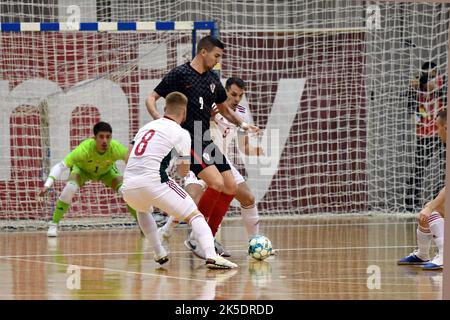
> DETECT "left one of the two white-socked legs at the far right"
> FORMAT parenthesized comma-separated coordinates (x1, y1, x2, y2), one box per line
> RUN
(397, 212, 433, 265)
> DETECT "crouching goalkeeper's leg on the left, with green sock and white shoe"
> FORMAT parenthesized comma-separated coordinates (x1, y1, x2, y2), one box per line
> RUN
(47, 166, 85, 237)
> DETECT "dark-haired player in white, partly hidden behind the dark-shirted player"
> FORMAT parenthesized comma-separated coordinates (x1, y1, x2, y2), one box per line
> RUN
(159, 77, 264, 257)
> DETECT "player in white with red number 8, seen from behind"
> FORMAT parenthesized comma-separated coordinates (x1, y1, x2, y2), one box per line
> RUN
(123, 92, 237, 269)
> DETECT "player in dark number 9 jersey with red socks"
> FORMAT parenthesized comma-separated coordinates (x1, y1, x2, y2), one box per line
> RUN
(146, 36, 259, 258)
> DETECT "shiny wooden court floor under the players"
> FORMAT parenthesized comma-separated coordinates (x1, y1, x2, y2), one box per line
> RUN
(0, 216, 442, 300)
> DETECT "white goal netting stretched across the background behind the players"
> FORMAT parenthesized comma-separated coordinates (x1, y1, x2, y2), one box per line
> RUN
(0, 0, 449, 227)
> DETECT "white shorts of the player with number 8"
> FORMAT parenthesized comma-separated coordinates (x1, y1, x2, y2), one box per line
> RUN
(123, 180, 197, 220)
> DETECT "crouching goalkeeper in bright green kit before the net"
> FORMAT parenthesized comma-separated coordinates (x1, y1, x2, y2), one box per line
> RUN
(39, 122, 136, 237)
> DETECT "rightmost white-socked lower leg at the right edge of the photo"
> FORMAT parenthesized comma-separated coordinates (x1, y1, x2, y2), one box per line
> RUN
(423, 208, 445, 270)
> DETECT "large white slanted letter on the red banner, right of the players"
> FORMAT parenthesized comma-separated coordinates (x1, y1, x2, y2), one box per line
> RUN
(241, 79, 306, 202)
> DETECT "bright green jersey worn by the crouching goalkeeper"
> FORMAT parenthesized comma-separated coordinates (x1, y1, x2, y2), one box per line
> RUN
(64, 138, 128, 177)
